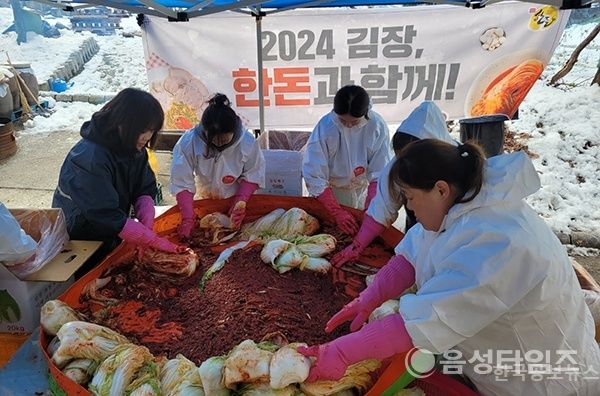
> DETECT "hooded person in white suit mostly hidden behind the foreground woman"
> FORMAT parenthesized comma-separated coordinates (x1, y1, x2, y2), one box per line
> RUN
(331, 100, 458, 267)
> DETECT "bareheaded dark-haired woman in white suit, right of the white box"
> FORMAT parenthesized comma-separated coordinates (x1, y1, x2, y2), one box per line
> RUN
(302, 85, 392, 235)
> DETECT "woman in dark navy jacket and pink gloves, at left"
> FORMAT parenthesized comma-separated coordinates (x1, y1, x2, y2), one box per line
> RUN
(52, 88, 186, 256)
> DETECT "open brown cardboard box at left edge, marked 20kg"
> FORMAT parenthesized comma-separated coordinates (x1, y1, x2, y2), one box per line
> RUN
(0, 209, 102, 333)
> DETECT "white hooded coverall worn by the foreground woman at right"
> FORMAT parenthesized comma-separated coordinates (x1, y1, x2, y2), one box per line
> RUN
(396, 152, 600, 396)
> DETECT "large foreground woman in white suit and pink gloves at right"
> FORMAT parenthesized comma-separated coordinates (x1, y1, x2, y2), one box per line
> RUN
(299, 139, 600, 396)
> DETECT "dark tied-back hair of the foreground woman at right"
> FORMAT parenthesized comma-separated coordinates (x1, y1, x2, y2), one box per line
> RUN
(389, 139, 485, 203)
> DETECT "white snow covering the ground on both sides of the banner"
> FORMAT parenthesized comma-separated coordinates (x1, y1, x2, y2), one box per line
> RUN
(0, 8, 600, 238)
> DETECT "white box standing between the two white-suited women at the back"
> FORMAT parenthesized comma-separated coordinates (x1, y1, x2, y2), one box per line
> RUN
(257, 150, 302, 196)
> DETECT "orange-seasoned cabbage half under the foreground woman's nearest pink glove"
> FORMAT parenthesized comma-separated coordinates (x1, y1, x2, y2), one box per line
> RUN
(300, 359, 381, 396)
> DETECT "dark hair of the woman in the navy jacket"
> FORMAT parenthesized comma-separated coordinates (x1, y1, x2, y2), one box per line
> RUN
(93, 88, 165, 150)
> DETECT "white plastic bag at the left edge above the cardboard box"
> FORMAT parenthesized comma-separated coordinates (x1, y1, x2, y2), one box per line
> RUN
(0, 203, 37, 266)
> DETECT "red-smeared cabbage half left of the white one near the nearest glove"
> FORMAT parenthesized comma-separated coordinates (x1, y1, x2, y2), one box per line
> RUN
(224, 340, 273, 389)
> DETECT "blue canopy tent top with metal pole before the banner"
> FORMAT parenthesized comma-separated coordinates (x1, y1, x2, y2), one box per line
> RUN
(24, 0, 598, 132)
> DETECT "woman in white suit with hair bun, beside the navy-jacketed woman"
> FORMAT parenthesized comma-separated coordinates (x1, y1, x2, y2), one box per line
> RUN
(170, 94, 265, 239)
